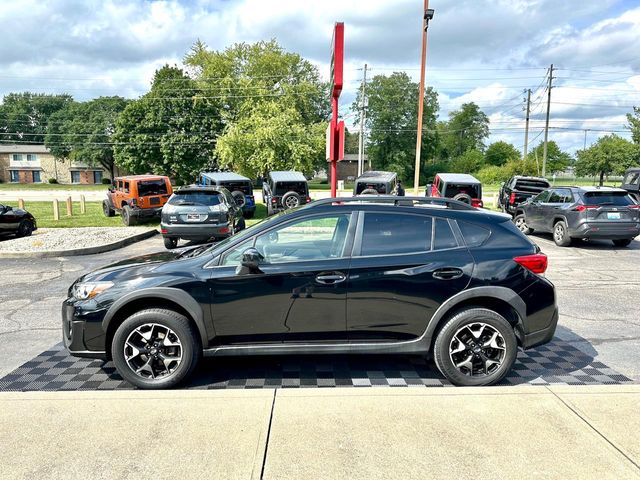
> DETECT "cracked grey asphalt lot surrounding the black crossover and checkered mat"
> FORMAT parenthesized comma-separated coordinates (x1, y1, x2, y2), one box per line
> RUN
(0, 235, 640, 385)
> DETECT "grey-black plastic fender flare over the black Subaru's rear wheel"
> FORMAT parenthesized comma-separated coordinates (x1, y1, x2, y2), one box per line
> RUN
(422, 286, 527, 348)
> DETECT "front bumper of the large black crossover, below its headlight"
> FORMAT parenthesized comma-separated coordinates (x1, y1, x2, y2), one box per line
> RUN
(62, 299, 107, 359)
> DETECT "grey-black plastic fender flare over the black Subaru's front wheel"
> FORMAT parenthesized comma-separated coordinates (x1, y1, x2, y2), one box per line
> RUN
(102, 287, 209, 346)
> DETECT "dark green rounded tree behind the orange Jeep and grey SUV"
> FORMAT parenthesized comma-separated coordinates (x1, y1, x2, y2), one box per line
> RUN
(113, 65, 222, 183)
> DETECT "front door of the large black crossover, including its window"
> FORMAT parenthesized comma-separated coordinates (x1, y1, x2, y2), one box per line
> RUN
(209, 212, 355, 344)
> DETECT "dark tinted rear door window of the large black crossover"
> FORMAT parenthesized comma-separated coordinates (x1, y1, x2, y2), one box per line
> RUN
(360, 213, 432, 256)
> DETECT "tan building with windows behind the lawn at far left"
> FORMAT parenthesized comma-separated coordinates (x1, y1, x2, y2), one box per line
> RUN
(0, 144, 117, 184)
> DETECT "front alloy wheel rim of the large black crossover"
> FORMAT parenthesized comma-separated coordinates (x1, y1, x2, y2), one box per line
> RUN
(124, 323, 183, 380)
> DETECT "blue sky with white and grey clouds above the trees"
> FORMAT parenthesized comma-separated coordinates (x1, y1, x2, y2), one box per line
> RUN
(0, 0, 640, 152)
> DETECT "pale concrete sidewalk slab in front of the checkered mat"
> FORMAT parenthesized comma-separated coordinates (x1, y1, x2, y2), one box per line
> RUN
(0, 385, 640, 479)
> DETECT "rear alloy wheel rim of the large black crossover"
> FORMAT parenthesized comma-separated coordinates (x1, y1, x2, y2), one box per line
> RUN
(449, 322, 506, 378)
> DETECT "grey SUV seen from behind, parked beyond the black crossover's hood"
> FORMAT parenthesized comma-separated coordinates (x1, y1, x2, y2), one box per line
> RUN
(160, 185, 245, 249)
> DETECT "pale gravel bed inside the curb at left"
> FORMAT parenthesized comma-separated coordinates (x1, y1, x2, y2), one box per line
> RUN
(0, 227, 157, 252)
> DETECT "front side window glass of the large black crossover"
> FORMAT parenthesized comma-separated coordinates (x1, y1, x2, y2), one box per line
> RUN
(255, 214, 350, 263)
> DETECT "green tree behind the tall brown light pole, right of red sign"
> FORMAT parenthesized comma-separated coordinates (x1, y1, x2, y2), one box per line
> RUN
(351, 72, 439, 182)
